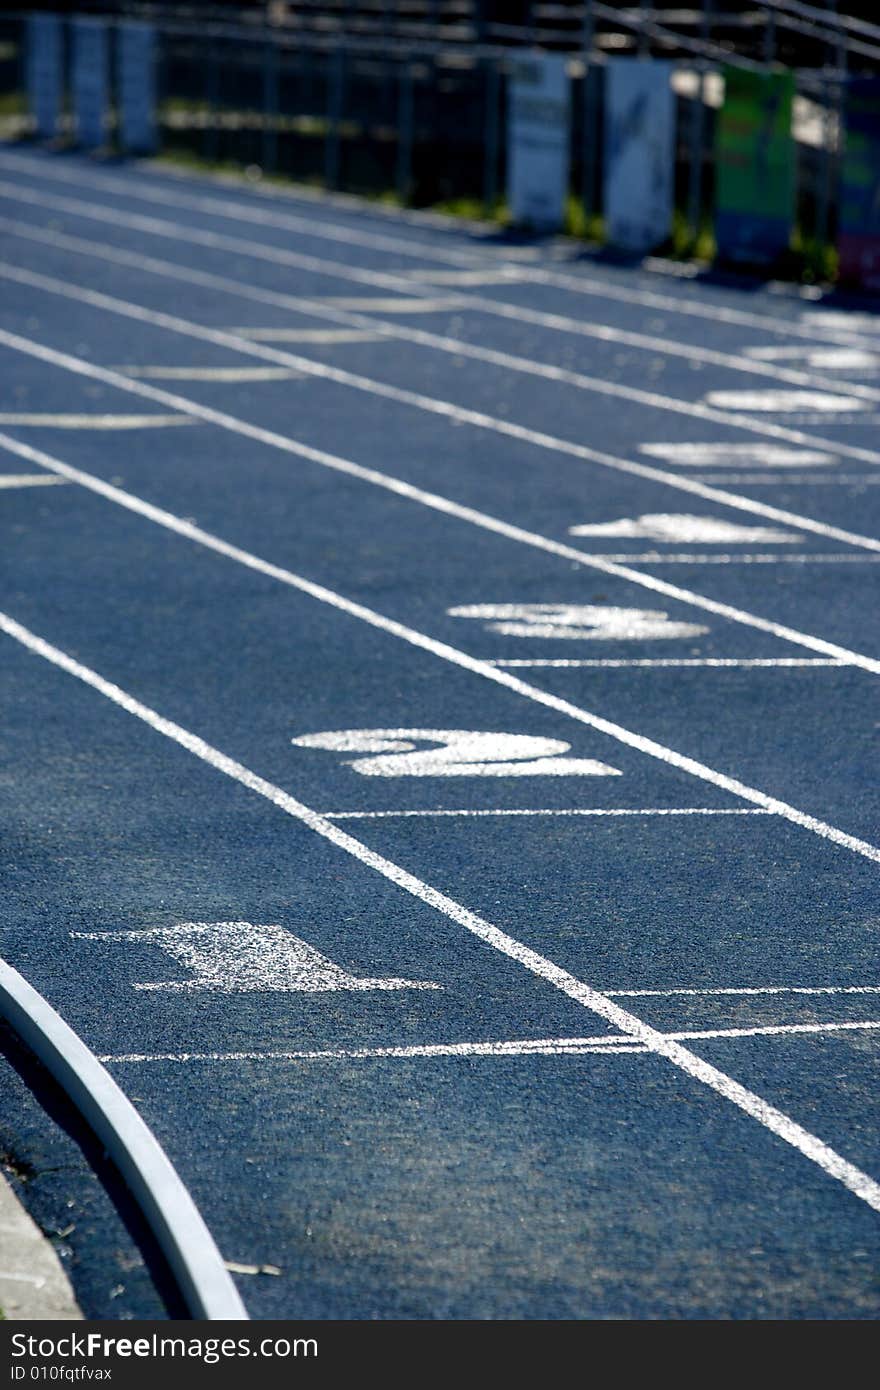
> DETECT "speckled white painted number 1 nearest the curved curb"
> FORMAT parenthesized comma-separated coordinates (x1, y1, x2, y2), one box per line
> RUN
(71, 922, 442, 994)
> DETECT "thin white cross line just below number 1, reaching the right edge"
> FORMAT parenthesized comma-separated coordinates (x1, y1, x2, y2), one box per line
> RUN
(100, 1020, 880, 1065)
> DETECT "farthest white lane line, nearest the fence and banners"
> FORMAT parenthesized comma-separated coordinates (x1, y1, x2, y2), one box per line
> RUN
(0, 153, 876, 349)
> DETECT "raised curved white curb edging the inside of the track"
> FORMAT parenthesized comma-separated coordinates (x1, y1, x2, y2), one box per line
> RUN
(0, 959, 247, 1321)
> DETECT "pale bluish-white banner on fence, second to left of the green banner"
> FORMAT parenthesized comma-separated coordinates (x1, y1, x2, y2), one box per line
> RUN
(507, 53, 571, 231)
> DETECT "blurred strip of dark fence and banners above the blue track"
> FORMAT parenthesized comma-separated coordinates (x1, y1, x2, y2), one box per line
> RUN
(0, 0, 880, 291)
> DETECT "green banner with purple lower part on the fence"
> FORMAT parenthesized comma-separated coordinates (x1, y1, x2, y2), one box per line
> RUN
(715, 67, 795, 263)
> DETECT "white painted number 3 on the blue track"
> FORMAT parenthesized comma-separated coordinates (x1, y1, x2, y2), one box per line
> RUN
(446, 603, 709, 642)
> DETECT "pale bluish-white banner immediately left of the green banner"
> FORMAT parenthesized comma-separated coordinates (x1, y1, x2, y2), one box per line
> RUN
(603, 58, 676, 252)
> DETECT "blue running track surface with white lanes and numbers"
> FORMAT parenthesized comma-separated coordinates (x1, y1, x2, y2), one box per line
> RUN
(0, 146, 880, 1319)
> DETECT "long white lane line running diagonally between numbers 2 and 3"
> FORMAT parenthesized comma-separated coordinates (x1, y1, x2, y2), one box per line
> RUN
(0, 435, 880, 863)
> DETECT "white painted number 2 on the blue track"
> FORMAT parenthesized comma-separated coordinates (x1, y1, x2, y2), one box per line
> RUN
(291, 728, 620, 777)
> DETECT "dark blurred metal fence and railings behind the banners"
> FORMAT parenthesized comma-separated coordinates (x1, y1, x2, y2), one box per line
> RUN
(0, 0, 880, 268)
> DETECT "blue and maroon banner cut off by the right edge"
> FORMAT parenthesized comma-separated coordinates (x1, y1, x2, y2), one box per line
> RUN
(837, 78, 880, 289)
